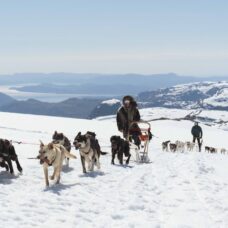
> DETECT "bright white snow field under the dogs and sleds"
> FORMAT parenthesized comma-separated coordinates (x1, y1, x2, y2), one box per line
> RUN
(0, 109, 228, 228)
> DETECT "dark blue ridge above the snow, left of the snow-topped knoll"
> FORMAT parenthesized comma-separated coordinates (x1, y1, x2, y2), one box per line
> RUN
(0, 98, 101, 119)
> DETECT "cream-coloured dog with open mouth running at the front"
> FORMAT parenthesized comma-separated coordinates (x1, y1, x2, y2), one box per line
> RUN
(37, 142, 76, 186)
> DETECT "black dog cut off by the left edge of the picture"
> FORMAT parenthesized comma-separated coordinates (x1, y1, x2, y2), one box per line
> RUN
(0, 139, 22, 174)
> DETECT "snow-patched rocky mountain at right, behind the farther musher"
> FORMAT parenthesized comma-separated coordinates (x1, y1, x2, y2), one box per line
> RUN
(138, 81, 228, 110)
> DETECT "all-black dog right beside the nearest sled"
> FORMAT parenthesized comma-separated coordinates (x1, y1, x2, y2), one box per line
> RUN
(110, 135, 131, 165)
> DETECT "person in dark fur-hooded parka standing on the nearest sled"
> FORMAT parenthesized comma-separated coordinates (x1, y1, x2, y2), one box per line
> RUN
(116, 96, 141, 147)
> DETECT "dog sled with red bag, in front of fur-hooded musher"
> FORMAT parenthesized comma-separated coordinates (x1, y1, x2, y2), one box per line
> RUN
(127, 121, 151, 163)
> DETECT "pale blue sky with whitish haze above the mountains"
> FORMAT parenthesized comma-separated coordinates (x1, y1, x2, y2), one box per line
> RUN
(0, 0, 228, 76)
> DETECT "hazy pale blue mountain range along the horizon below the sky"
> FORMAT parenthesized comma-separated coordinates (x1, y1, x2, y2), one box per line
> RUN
(0, 73, 228, 96)
